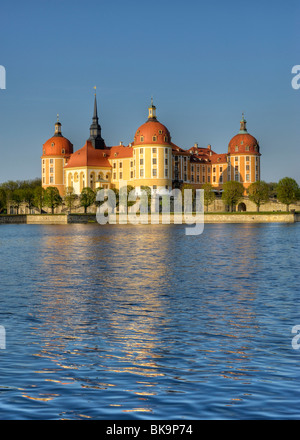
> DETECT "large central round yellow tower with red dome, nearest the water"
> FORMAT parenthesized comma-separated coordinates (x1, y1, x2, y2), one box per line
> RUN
(132, 99, 172, 192)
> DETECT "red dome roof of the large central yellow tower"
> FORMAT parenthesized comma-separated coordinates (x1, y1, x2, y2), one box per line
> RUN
(134, 119, 171, 145)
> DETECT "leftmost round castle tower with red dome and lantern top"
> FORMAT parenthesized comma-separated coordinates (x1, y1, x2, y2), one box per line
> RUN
(41, 115, 73, 196)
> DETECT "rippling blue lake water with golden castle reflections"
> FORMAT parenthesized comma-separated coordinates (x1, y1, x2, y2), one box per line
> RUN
(0, 223, 300, 420)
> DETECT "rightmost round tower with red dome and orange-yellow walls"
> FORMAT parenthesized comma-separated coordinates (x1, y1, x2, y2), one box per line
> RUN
(227, 114, 261, 188)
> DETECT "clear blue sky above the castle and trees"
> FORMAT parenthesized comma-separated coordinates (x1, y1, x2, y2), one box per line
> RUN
(0, 0, 300, 184)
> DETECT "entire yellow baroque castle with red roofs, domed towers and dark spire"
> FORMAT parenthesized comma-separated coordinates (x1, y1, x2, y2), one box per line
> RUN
(41, 94, 261, 196)
